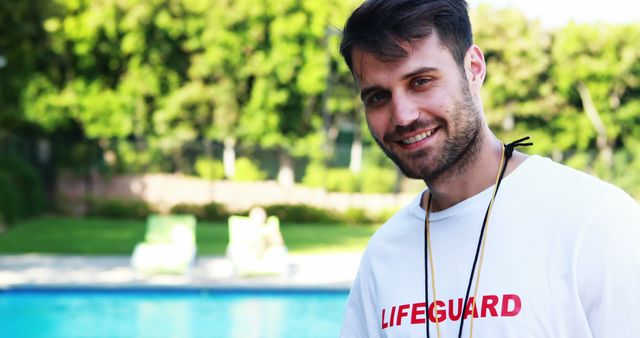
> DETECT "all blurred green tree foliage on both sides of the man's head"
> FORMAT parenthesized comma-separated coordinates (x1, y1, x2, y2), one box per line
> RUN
(0, 0, 640, 198)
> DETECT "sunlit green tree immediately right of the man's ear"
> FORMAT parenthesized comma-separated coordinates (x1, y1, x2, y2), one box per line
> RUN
(471, 5, 564, 158)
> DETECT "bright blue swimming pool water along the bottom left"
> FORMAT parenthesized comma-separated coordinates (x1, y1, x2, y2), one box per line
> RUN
(0, 289, 347, 338)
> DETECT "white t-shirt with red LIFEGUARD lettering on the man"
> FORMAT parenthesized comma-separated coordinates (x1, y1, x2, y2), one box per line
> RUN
(340, 156, 640, 338)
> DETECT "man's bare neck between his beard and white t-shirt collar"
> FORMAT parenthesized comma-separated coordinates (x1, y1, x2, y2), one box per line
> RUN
(422, 132, 526, 211)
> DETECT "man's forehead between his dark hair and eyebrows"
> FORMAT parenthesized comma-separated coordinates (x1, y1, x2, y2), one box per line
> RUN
(352, 32, 457, 88)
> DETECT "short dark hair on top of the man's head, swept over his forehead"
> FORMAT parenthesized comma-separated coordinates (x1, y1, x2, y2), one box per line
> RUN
(340, 0, 473, 71)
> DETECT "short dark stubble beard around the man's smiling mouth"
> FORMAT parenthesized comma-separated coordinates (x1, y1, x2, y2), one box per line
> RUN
(370, 84, 482, 182)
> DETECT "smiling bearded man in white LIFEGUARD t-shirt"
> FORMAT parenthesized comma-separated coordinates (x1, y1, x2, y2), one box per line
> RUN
(341, 0, 640, 338)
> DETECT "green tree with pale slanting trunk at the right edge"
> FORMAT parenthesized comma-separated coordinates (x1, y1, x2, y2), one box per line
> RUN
(552, 24, 640, 193)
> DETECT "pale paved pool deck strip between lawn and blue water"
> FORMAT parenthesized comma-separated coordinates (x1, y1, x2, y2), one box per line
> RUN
(0, 253, 361, 290)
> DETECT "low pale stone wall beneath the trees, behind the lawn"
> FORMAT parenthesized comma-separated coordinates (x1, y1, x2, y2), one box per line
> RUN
(57, 174, 416, 212)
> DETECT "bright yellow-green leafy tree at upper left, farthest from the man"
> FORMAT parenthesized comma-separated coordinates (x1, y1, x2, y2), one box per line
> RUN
(22, 0, 194, 172)
